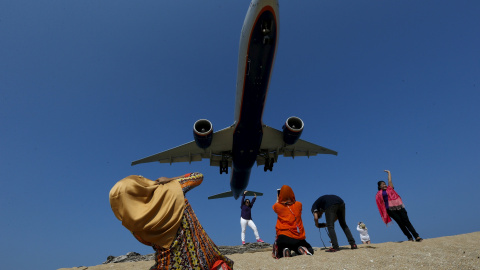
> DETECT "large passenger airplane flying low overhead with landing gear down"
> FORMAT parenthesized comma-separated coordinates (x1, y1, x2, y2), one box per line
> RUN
(132, 0, 337, 199)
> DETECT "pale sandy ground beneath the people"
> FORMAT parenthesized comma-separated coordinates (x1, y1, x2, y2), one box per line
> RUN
(58, 232, 480, 270)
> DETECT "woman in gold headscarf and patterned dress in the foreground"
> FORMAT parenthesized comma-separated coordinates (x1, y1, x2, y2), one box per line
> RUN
(110, 173, 233, 270)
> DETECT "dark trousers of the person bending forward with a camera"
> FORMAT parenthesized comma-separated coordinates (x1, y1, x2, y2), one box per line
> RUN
(325, 203, 355, 249)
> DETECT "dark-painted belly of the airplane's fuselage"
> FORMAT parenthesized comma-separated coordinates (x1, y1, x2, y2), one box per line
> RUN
(230, 5, 277, 199)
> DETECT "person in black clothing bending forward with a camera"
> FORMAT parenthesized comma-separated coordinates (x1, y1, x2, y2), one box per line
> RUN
(312, 195, 357, 252)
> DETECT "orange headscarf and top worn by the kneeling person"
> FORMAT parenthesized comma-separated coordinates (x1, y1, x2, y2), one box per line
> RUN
(273, 185, 305, 240)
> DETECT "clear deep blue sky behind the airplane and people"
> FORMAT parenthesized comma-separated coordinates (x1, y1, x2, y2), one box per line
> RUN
(0, 0, 480, 269)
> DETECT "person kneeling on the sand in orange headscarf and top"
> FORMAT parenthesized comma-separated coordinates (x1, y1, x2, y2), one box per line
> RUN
(273, 185, 313, 259)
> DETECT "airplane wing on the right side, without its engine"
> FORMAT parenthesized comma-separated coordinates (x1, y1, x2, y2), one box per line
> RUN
(257, 125, 338, 166)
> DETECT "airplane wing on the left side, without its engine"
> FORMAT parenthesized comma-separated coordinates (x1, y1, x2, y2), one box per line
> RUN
(132, 126, 234, 166)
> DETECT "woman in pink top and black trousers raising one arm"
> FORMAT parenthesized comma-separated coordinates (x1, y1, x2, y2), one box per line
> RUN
(375, 170, 423, 242)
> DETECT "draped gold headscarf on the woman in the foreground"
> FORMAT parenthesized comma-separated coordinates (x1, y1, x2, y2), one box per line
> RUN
(110, 175, 185, 248)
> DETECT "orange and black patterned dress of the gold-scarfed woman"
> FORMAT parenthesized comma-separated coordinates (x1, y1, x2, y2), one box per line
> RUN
(135, 173, 233, 270)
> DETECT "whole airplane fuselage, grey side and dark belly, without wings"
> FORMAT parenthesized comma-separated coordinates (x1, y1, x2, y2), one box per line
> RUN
(230, 0, 279, 198)
